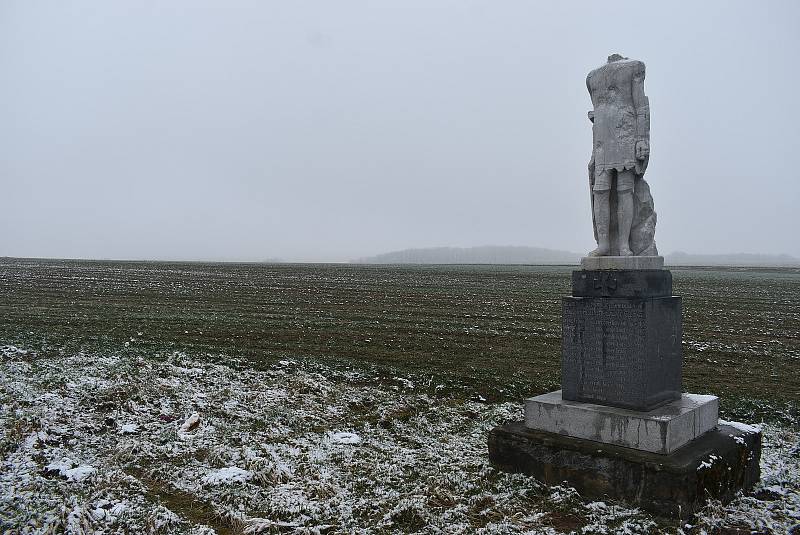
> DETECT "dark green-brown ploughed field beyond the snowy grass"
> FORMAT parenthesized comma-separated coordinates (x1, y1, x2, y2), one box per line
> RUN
(0, 259, 800, 423)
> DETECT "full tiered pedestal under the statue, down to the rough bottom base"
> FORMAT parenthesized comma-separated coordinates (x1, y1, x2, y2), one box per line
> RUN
(489, 257, 761, 516)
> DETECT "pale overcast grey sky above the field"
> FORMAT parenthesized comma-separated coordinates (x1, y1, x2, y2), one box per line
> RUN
(0, 0, 800, 260)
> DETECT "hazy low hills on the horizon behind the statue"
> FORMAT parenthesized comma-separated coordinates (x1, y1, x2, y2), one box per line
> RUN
(352, 245, 800, 267)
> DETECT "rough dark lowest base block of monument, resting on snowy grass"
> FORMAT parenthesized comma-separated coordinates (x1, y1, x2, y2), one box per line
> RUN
(488, 422, 761, 518)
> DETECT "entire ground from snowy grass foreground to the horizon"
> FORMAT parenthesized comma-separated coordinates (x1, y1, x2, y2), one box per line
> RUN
(0, 259, 800, 534)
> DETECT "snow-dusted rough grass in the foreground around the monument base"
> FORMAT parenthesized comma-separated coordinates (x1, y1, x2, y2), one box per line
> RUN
(0, 346, 800, 534)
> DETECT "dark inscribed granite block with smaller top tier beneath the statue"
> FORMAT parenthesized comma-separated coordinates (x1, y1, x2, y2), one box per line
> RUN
(561, 269, 682, 411)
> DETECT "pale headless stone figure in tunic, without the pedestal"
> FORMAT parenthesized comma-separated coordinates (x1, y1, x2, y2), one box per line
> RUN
(586, 54, 658, 256)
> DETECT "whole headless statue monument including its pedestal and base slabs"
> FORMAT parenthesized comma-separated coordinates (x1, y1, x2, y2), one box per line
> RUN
(488, 54, 756, 520)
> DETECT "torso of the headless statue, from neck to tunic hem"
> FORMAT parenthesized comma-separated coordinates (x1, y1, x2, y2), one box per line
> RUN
(586, 60, 644, 173)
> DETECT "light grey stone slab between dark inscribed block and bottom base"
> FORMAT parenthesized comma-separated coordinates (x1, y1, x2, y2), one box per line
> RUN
(525, 390, 719, 455)
